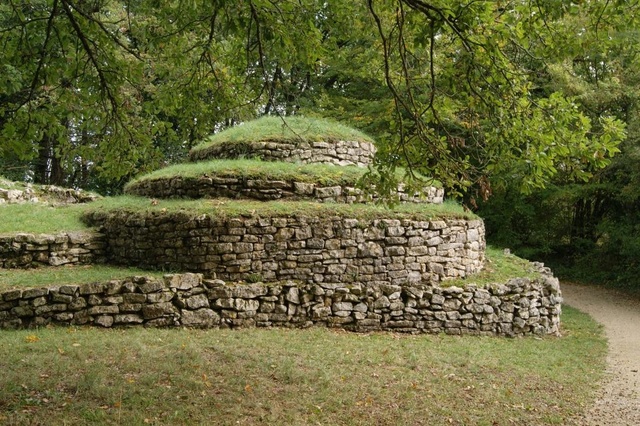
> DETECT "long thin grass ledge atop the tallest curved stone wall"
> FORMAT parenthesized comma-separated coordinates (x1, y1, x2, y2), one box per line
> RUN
(85, 196, 476, 220)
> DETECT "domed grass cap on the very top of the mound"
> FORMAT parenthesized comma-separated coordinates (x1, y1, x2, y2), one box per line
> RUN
(192, 117, 373, 156)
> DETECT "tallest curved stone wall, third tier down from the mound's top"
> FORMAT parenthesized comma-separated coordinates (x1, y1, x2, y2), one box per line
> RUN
(89, 212, 485, 285)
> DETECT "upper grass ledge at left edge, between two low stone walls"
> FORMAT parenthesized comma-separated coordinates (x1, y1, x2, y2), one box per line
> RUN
(0, 203, 89, 234)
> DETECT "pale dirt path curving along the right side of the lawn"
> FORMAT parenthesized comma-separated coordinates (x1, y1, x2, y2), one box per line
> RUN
(561, 283, 640, 426)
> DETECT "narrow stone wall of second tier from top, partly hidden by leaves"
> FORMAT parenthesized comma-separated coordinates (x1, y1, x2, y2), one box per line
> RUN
(125, 176, 444, 204)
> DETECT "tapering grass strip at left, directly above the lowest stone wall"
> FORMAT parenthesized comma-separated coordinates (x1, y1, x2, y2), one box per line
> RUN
(0, 265, 163, 291)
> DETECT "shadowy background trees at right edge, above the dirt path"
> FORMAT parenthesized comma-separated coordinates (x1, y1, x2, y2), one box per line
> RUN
(479, 2, 640, 290)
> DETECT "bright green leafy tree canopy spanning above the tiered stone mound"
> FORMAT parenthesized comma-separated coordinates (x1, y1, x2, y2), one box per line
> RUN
(0, 0, 635, 196)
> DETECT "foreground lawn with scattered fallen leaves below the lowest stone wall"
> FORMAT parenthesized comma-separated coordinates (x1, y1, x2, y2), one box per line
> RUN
(0, 308, 606, 425)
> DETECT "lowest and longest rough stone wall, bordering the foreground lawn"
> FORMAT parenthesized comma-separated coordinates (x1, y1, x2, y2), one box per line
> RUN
(0, 274, 562, 336)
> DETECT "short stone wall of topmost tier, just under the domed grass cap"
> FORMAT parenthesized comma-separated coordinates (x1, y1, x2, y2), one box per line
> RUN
(189, 141, 376, 167)
